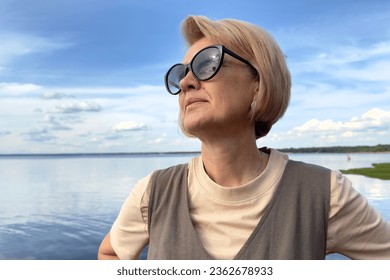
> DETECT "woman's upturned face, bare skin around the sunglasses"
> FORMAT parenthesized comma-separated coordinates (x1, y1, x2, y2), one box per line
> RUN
(179, 38, 255, 140)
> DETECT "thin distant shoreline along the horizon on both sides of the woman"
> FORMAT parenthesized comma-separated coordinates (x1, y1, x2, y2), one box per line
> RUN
(0, 145, 390, 158)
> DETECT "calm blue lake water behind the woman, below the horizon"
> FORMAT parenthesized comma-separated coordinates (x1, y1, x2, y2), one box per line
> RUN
(0, 151, 390, 260)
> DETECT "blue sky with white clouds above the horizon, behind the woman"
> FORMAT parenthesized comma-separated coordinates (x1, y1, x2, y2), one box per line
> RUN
(0, 0, 390, 153)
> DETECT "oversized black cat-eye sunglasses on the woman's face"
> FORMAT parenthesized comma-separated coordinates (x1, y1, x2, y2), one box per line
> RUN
(165, 45, 258, 95)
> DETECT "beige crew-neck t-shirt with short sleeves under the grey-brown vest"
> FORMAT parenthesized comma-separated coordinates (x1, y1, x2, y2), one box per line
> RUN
(110, 150, 390, 259)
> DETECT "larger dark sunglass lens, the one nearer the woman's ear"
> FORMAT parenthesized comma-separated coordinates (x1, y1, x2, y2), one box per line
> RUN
(191, 47, 221, 81)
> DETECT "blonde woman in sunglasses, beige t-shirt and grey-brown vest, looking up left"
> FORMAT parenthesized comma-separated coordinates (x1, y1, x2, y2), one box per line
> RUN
(98, 16, 390, 259)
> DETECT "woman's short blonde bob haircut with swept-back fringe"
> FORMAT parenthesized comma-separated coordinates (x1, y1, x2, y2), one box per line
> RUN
(180, 16, 291, 138)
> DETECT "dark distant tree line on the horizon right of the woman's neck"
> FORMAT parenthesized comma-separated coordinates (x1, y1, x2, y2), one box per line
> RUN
(278, 144, 390, 154)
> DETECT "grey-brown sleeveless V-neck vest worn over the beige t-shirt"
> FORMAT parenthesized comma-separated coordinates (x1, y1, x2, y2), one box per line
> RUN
(148, 160, 330, 260)
